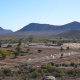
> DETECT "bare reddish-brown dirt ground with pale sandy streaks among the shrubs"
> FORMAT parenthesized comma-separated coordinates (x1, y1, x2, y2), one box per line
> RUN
(0, 43, 80, 80)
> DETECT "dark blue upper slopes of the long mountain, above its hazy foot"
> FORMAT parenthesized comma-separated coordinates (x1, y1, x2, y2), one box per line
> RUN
(17, 21, 80, 32)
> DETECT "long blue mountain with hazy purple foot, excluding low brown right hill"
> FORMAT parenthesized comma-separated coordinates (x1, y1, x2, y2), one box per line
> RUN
(15, 21, 80, 36)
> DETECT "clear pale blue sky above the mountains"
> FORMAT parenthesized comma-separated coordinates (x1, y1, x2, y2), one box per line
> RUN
(0, 0, 80, 31)
